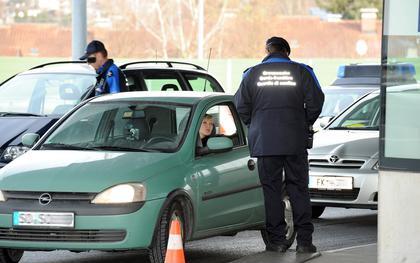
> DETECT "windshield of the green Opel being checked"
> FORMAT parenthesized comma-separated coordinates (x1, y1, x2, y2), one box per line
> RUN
(41, 101, 191, 152)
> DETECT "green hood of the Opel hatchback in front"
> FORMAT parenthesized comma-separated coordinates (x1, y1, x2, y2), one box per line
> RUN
(0, 150, 180, 192)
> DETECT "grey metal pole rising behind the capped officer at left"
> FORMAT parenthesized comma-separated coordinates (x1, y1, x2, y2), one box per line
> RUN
(71, 0, 87, 60)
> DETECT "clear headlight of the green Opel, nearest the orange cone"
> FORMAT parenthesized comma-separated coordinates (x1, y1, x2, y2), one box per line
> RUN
(92, 184, 146, 204)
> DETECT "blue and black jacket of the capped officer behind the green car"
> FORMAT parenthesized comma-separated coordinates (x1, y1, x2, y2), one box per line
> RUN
(95, 59, 125, 95)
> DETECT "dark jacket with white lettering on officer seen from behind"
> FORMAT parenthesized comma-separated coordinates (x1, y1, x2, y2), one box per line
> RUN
(235, 54, 324, 157)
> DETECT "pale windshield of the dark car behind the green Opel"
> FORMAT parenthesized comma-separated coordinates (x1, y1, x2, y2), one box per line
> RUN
(0, 73, 96, 116)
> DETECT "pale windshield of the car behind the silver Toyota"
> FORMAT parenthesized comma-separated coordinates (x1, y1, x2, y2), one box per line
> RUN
(319, 88, 373, 118)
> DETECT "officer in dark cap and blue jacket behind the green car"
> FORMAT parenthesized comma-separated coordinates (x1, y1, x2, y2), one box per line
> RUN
(80, 40, 127, 96)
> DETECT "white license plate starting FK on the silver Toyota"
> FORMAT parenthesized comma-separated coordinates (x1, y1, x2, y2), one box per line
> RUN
(309, 176, 353, 190)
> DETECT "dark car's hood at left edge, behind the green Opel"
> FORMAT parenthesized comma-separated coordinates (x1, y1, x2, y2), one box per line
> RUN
(0, 116, 58, 149)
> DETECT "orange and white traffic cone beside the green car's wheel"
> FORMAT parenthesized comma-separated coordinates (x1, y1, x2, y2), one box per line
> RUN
(165, 219, 185, 263)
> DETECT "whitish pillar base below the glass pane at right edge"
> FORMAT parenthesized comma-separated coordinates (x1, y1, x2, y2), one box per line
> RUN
(378, 171, 420, 263)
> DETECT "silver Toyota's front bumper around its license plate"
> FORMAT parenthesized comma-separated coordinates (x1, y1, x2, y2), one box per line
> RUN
(309, 169, 378, 209)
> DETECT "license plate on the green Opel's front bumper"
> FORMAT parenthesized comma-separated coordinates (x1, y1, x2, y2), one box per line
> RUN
(13, 211, 74, 227)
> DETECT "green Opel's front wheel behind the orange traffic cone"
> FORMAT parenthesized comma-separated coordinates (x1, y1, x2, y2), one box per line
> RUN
(149, 201, 185, 263)
